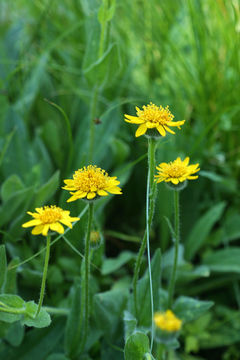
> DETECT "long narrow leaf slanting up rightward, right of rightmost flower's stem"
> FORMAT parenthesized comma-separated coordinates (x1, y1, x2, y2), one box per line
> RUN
(185, 202, 226, 260)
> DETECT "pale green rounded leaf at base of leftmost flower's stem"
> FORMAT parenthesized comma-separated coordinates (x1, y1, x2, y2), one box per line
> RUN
(21, 301, 51, 328)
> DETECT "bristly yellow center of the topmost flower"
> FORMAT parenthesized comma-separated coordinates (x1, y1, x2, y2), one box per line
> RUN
(137, 103, 174, 125)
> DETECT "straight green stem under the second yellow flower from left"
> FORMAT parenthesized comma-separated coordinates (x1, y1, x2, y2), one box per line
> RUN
(82, 202, 93, 349)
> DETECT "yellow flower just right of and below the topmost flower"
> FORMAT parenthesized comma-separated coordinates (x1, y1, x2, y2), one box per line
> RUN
(155, 157, 200, 185)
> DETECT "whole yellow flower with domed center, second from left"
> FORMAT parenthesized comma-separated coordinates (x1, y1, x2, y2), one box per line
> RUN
(63, 165, 122, 202)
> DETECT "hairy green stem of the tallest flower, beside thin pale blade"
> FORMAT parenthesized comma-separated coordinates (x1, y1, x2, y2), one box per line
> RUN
(133, 138, 156, 317)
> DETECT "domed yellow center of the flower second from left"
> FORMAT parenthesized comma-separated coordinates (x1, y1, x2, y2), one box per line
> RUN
(73, 165, 108, 192)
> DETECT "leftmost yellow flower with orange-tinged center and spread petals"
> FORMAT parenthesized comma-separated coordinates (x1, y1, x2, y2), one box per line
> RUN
(22, 205, 79, 236)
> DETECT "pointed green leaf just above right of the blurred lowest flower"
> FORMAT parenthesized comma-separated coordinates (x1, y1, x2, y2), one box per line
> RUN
(173, 296, 214, 322)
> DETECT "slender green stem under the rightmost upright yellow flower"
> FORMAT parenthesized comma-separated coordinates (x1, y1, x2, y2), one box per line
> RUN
(168, 190, 180, 309)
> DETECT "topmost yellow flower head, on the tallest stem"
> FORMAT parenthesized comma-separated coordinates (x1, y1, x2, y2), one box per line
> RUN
(124, 103, 185, 137)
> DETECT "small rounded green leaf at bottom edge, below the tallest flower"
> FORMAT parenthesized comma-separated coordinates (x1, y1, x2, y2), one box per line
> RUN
(124, 331, 150, 360)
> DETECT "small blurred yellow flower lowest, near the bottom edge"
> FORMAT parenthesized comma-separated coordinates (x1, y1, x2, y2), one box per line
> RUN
(154, 310, 182, 332)
